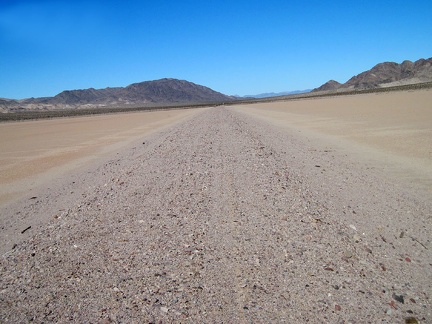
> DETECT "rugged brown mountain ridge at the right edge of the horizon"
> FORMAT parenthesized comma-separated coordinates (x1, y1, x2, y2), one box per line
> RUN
(312, 58, 432, 92)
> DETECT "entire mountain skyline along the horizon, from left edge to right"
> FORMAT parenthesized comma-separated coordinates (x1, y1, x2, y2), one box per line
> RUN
(4, 58, 432, 112)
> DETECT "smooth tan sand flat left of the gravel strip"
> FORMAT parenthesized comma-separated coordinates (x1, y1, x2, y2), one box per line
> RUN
(0, 109, 205, 206)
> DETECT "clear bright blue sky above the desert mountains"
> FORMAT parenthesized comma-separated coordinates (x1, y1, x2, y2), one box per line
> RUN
(0, 0, 432, 99)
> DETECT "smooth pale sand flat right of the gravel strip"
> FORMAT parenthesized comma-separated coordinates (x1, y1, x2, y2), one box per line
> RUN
(234, 90, 432, 192)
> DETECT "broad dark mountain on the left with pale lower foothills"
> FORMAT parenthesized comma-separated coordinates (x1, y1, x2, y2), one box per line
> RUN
(0, 79, 235, 111)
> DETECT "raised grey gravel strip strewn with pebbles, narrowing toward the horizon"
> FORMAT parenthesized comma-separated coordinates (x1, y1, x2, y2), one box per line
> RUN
(0, 107, 432, 323)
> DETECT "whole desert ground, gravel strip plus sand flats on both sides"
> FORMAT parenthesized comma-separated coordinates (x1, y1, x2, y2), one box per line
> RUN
(0, 90, 432, 323)
